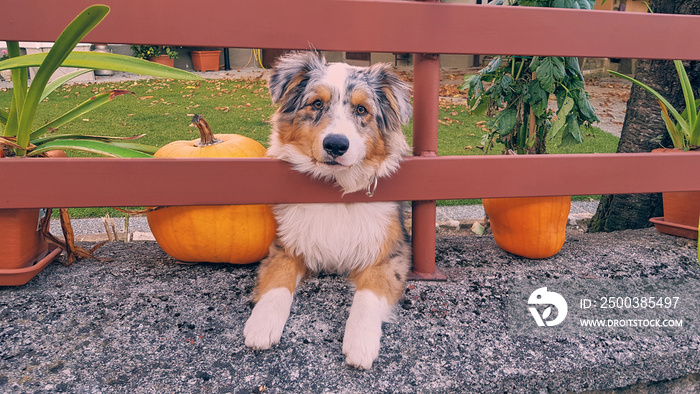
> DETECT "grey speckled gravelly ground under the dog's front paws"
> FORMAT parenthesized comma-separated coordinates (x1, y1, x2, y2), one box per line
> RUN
(0, 227, 700, 393)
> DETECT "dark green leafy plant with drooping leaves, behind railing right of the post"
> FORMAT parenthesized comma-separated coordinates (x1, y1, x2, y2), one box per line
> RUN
(461, 0, 599, 154)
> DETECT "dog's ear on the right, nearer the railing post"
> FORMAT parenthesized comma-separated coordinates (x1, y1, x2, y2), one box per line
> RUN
(369, 63, 413, 129)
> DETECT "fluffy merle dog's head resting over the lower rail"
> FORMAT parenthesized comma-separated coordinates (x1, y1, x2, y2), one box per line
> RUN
(268, 52, 411, 193)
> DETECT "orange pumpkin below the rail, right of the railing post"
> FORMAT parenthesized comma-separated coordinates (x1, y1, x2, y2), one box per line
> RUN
(483, 196, 571, 259)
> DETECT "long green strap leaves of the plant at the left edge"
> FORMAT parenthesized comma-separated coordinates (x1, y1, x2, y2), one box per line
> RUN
(0, 5, 202, 157)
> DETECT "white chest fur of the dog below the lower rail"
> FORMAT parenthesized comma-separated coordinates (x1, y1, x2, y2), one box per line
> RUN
(274, 202, 399, 273)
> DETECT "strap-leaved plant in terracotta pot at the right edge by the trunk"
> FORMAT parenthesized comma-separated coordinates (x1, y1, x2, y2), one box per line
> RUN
(608, 60, 700, 239)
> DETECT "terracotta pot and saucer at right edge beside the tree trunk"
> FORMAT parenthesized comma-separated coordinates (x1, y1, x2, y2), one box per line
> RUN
(649, 148, 700, 239)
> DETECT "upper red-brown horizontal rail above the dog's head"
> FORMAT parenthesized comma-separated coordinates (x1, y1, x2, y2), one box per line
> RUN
(0, 0, 700, 60)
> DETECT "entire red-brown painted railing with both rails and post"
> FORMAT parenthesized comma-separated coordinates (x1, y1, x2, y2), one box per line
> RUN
(0, 0, 700, 274)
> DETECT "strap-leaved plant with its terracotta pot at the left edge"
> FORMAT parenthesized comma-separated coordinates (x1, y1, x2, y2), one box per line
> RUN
(0, 5, 202, 285)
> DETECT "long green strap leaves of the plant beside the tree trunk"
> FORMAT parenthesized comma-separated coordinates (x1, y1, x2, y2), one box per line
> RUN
(608, 60, 700, 151)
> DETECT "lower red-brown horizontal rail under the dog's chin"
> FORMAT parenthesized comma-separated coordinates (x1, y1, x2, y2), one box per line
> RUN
(0, 152, 700, 208)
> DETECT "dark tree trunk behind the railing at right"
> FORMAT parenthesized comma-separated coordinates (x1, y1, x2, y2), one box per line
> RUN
(589, 0, 700, 232)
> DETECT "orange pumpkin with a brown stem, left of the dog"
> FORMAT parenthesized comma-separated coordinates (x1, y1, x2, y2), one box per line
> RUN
(146, 115, 276, 264)
